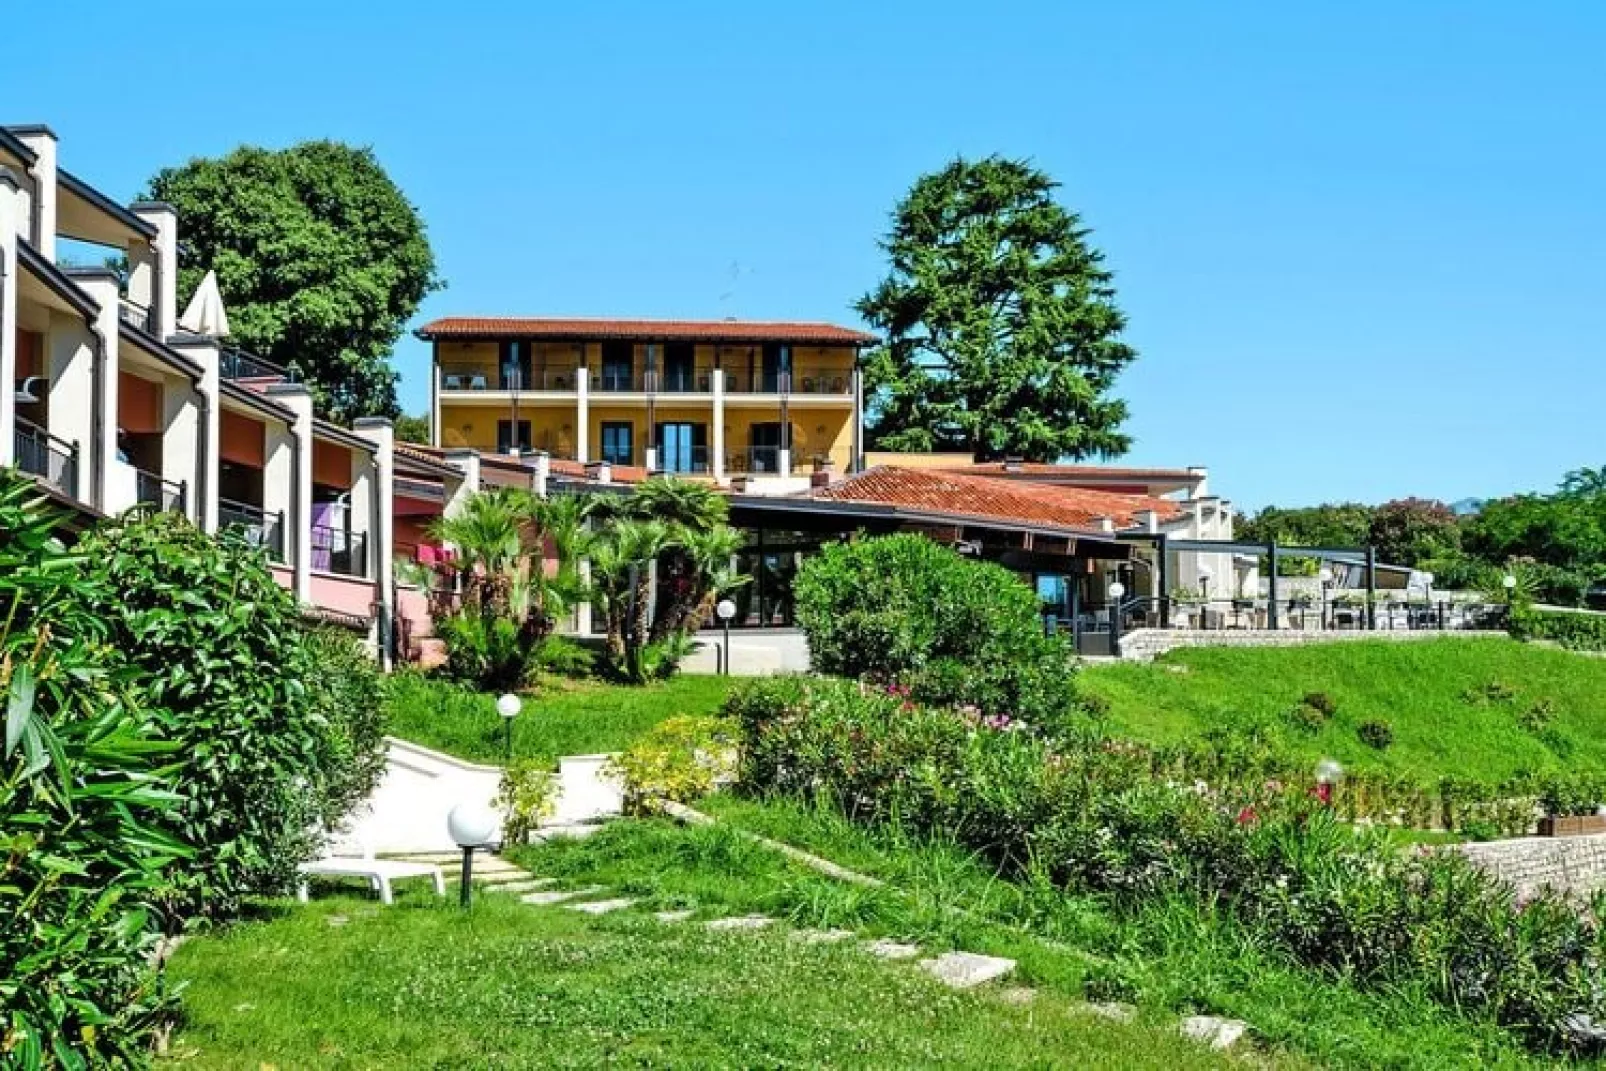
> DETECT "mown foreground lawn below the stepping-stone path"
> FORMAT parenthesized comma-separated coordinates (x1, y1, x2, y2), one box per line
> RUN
(164, 898, 1221, 1068)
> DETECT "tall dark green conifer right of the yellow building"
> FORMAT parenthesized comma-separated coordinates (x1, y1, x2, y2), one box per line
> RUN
(858, 156, 1137, 461)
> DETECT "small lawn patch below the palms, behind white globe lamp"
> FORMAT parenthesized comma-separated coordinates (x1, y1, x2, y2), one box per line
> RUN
(389, 673, 731, 763)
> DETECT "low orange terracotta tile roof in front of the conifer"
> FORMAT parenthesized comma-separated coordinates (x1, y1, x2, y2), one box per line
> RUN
(814, 466, 1182, 530)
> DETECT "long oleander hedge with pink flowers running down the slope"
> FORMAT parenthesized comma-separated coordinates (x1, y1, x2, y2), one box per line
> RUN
(728, 678, 1606, 1053)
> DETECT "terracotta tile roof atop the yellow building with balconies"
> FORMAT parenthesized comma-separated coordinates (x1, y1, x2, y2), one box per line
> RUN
(407, 316, 877, 345)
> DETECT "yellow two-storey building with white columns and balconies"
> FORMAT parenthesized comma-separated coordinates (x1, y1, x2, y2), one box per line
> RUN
(418, 316, 875, 482)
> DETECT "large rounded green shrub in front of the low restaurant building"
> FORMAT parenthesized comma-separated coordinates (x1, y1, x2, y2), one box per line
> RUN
(793, 535, 1076, 724)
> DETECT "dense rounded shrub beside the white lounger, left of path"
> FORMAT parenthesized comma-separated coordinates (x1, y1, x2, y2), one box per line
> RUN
(80, 514, 381, 917)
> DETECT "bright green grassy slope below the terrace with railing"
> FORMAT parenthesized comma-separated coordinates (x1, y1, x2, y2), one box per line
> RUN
(1079, 639, 1606, 779)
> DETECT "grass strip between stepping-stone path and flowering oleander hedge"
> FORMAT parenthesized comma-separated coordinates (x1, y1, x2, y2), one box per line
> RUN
(674, 795, 1528, 1068)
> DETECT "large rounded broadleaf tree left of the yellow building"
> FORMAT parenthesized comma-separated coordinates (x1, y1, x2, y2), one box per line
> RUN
(148, 141, 440, 421)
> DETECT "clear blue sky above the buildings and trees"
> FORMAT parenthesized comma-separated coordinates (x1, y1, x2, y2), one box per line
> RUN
(0, 0, 1606, 507)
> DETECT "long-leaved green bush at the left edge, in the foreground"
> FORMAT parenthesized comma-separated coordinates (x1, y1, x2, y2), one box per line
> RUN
(0, 470, 185, 1068)
